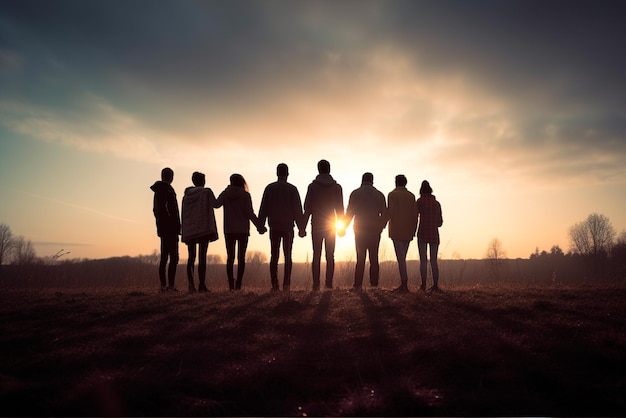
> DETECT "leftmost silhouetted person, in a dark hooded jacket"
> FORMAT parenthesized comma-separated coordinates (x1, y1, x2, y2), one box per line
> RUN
(150, 167, 180, 291)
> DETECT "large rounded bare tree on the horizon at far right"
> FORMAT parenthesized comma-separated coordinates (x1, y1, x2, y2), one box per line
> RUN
(569, 213, 615, 256)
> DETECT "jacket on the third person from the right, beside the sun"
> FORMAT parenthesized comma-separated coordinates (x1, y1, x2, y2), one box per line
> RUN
(346, 182, 387, 234)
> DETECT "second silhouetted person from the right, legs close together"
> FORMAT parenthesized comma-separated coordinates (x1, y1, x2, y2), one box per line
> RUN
(387, 174, 417, 292)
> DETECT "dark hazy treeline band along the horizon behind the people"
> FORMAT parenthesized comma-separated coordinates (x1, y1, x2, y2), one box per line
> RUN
(0, 254, 626, 291)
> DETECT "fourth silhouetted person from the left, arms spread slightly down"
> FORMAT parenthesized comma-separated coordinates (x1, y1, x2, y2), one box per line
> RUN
(259, 163, 304, 291)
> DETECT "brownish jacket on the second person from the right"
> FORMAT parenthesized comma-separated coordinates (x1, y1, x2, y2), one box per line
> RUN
(387, 186, 417, 241)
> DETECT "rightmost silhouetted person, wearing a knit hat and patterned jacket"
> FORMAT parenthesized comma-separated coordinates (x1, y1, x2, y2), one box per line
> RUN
(416, 180, 443, 291)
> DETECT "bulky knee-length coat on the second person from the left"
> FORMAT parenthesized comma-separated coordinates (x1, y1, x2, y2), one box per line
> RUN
(182, 186, 218, 243)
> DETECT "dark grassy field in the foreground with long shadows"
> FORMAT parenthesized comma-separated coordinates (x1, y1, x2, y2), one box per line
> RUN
(0, 286, 626, 416)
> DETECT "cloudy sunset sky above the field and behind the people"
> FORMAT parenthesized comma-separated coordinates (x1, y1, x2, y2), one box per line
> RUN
(0, 0, 626, 261)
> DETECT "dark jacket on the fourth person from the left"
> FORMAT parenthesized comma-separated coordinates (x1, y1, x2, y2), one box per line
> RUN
(259, 179, 302, 231)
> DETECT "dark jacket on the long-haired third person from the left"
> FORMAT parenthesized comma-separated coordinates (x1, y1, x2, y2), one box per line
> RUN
(216, 185, 262, 235)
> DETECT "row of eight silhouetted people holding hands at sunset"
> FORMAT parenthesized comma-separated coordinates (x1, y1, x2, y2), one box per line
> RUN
(150, 160, 443, 292)
